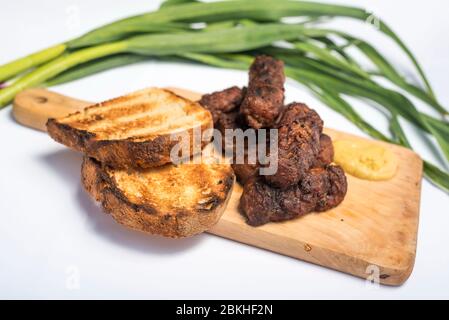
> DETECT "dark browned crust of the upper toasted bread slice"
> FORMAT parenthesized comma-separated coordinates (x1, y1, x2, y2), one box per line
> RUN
(47, 90, 213, 169)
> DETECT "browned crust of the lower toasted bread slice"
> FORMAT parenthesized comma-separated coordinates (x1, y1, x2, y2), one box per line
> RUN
(81, 157, 235, 238)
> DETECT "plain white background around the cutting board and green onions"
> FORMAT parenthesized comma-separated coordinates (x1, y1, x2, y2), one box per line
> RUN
(0, 0, 449, 299)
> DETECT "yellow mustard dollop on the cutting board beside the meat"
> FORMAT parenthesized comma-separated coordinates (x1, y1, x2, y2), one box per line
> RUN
(334, 140, 398, 181)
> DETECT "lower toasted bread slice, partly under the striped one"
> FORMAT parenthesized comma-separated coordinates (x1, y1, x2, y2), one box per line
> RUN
(81, 152, 235, 238)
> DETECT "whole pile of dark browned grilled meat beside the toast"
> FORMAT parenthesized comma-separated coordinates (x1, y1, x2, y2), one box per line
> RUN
(200, 56, 347, 226)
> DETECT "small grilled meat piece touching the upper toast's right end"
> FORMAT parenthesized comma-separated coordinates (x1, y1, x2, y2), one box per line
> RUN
(199, 86, 246, 124)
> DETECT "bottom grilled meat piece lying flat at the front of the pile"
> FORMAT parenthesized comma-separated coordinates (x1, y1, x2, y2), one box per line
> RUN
(239, 165, 347, 226)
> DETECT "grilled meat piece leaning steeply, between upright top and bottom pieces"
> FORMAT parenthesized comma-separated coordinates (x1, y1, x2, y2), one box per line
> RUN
(265, 103, 323, 189)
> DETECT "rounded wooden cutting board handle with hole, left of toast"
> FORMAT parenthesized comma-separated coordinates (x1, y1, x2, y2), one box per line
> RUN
(13, 88, 201, 131)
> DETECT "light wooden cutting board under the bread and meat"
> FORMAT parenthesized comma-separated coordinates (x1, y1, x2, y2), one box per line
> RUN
(13, 88, 422, 285)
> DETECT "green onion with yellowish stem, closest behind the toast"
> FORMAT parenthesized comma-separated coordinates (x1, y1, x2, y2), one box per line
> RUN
(0, 24, 304, 108)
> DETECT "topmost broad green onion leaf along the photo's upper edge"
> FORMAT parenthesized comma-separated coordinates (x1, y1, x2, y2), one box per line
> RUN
(69, 0, 369, 48)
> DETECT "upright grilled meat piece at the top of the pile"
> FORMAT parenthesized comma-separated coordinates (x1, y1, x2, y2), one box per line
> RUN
(240, 56, 285, 129)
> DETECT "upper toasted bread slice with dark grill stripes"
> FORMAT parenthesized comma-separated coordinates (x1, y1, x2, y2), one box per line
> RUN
(47, 88, 213, 169)
